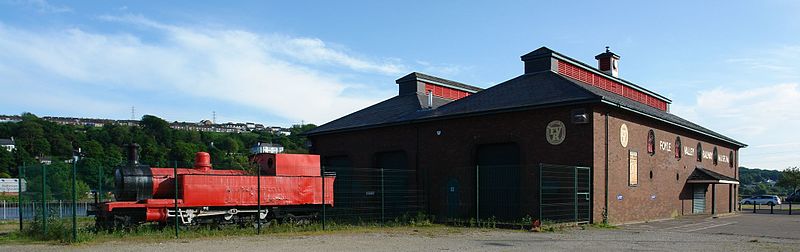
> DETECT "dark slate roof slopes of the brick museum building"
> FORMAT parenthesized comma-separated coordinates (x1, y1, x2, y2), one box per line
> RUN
(306, 55, 747, 147)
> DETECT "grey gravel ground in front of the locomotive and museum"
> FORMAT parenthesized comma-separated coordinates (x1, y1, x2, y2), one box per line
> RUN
(0, 227, 800, 252)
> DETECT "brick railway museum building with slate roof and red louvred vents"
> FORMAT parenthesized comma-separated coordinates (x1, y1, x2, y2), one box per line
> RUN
(307, 47, 746, 223)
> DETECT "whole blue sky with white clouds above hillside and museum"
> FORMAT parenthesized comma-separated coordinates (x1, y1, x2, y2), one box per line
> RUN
(0, 0, 800, 169)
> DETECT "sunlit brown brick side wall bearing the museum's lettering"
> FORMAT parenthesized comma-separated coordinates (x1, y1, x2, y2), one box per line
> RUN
(594, 107, 738, 223)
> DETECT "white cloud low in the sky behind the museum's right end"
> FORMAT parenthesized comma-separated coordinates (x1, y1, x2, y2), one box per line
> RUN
(672, 83, 800, 169)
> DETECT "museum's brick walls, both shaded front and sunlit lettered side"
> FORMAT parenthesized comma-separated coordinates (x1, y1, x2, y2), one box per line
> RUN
(310, 105, 738, 223)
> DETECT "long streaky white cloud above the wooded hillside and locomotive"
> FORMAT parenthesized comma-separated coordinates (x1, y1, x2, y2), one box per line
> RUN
(0, 16, 412, 123)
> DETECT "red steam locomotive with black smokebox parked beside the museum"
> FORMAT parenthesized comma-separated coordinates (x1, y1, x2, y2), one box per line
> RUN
(95, 144, 335, 229)
